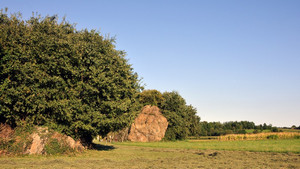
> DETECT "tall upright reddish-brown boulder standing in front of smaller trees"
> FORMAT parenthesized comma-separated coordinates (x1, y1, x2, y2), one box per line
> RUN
(128, 105, 168, 142)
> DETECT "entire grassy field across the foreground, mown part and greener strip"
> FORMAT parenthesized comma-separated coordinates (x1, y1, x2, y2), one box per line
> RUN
(0, 139, 300, 168)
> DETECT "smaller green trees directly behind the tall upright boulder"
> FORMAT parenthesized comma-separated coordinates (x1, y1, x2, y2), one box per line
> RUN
(139, 90, 200, 140)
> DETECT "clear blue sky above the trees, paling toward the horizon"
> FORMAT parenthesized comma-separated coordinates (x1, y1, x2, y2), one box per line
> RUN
(0, 0, 300, 126)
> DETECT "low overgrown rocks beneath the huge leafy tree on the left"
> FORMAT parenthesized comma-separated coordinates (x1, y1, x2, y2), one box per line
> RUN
(0, 123, 85, 156)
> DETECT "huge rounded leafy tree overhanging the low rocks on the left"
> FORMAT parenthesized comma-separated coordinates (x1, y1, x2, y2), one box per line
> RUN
(0, 11, 140, 143)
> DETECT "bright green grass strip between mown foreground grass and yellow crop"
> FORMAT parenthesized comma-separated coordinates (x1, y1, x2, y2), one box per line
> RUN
(114, 139, 300, 153)
